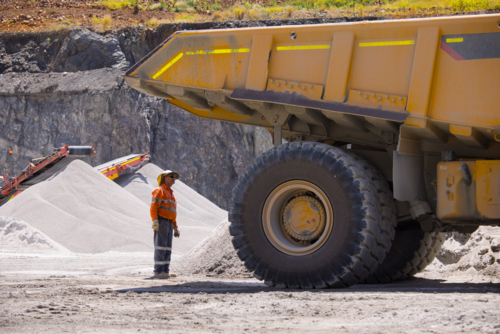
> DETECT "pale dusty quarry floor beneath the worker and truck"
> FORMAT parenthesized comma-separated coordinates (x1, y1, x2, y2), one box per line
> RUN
(0, 252, 500, 333)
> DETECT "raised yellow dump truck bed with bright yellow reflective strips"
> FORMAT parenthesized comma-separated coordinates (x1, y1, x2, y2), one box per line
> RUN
(124, 14, 500, 153)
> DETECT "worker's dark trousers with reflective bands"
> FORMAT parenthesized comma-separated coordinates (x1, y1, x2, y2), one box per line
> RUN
(154, 217, 174, 274)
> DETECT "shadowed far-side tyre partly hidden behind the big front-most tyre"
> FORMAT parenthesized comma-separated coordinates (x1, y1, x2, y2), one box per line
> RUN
(365, 221, 444, 284)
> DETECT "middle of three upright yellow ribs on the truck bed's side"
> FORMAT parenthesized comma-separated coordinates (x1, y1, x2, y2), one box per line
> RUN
(325, 31, 354, 102)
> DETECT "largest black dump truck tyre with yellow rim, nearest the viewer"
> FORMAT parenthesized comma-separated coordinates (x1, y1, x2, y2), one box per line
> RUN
(229, 142, 394, 288)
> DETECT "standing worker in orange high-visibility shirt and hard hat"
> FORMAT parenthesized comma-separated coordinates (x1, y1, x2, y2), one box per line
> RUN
(150, 170, 180, 279)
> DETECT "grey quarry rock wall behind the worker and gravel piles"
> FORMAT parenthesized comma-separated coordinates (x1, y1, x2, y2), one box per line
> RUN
(0, 25, 271, 209)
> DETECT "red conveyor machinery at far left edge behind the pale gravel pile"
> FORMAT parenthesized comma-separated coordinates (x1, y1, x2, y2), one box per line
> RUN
(0, 145, 95, 206)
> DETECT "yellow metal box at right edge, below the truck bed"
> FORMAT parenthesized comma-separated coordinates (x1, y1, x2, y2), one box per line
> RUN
(437, 160, 500, 221)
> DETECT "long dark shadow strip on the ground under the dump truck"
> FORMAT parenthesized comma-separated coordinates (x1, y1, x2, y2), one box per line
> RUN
(116, 278, 500, 294)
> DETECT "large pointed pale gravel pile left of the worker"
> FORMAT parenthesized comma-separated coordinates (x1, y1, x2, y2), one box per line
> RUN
(0, 160, 153, 253)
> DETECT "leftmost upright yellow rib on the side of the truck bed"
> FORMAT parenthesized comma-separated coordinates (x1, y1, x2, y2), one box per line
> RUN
(245, 35, 273, 90)
